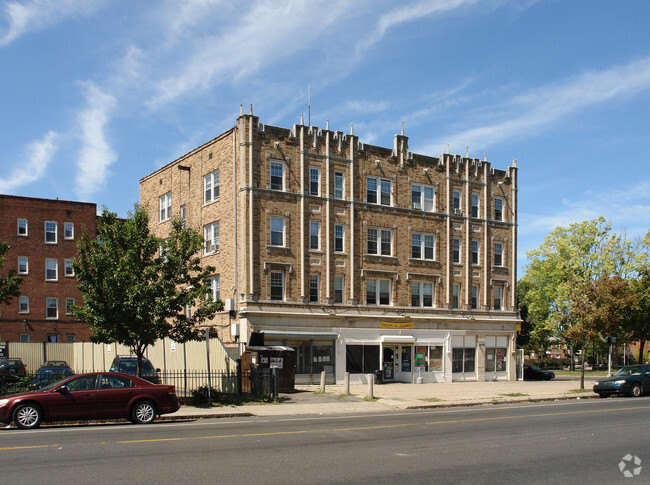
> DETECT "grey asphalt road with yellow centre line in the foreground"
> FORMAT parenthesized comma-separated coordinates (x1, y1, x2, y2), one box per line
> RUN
(0, 397, 650, 484)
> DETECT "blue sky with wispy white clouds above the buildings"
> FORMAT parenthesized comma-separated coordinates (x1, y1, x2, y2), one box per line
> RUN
(0, 0, 650, 276)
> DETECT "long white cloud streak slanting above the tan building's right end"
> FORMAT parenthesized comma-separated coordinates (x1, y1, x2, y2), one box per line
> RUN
(423, 58, 650, 153)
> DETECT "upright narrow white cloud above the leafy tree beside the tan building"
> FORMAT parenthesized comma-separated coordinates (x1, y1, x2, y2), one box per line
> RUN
(75, 83, 117, 200)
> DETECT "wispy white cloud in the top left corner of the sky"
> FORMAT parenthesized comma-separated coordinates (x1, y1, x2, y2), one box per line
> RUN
(0, 0, 103, 47)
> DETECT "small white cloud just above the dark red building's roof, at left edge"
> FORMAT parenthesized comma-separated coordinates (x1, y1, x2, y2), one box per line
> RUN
(0, 131, 59, 194)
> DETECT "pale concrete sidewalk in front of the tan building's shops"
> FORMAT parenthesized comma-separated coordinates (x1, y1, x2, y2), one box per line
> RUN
(160, 377, 597, 421)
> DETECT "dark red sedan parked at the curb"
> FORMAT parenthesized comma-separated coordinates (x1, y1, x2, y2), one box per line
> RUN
(0, 372, 180, 429)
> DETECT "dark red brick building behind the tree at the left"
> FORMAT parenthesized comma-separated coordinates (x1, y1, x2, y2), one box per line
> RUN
(0, 194, 97, 342)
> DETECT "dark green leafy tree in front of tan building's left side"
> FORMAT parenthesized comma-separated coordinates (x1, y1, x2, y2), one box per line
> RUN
(73, 205, 223, 375)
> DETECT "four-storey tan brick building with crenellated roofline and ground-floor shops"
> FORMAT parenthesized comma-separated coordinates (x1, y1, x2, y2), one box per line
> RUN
(140, 107, 520, 383)
